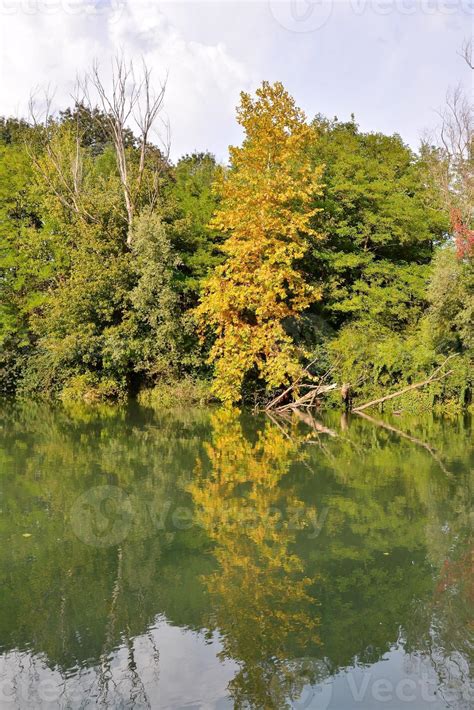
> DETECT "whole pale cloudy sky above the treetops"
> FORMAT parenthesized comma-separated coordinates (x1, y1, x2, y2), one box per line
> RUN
(0, 0, 474, 161)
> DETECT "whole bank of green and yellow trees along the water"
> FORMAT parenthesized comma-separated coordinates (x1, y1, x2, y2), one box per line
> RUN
(0, 63, 474, 410)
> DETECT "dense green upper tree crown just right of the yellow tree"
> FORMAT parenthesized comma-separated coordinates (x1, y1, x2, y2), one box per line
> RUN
(311, 117, 447, 330)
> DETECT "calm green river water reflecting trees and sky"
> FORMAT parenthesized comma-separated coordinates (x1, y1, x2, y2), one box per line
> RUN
(0, 404, 474, 710)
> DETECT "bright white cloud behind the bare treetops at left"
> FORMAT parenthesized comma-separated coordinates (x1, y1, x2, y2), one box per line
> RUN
(0, 0, 249, 158)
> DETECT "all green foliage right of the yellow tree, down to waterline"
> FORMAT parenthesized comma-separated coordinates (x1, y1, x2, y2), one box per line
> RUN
(296, 117, 472, 410)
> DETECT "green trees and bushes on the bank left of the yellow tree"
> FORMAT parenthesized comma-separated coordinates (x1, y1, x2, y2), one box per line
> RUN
(0, 107, 213, 398)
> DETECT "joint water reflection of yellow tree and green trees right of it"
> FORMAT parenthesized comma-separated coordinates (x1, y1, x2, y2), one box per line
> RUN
(189, 411, 469, 707)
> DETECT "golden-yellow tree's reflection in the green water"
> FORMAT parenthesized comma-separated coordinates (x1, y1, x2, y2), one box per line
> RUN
(190, 410, 318, 708)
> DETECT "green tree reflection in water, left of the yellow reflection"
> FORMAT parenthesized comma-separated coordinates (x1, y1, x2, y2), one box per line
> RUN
(0, 403, 212, 706)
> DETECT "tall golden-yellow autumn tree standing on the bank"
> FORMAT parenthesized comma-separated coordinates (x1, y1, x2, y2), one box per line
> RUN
(198, 82, 322, 402)
